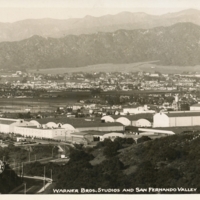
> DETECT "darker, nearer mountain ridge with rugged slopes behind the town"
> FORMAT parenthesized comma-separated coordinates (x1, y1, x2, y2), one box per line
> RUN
(0, 23, 200, 69)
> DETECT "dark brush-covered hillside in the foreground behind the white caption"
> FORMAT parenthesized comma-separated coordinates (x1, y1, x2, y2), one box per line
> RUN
(19, 131, 200, 194)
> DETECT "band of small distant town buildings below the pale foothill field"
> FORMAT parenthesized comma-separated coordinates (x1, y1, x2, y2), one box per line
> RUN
(0, 71, 200, 91)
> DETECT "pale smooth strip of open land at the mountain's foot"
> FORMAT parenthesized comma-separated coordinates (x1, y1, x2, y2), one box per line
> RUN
(28, 61, 200, 74)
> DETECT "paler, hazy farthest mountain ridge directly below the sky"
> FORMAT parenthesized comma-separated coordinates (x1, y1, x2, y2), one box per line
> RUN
(0, 9, 200, 42)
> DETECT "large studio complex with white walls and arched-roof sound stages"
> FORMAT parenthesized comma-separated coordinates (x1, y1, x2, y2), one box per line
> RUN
(0, 104, 200, 144)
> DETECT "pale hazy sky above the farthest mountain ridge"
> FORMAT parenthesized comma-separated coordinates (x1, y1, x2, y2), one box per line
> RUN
(0, 0, 200, 22)
